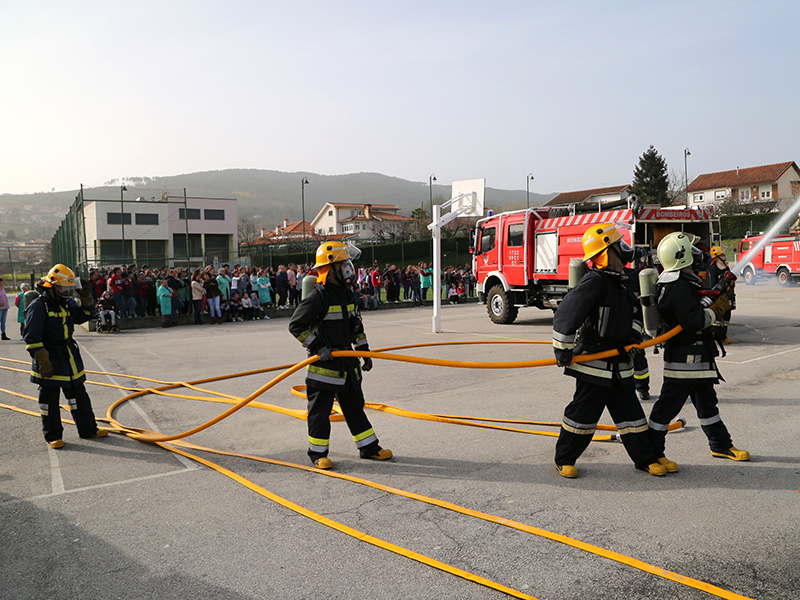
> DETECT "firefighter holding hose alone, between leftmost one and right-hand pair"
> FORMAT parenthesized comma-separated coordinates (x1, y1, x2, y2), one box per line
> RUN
(289, 242, 392, 469)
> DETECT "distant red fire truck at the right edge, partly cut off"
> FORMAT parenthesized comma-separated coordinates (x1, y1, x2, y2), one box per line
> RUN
(737, 235, 800, 286)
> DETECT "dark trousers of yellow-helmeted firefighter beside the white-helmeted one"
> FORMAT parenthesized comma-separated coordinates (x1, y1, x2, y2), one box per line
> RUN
(556, 378, 657, 469)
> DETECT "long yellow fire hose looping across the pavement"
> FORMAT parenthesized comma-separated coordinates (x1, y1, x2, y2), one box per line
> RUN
(0, 327, 749, 600)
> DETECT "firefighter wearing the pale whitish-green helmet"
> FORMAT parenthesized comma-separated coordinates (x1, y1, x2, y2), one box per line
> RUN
(650, 232, 750, 460)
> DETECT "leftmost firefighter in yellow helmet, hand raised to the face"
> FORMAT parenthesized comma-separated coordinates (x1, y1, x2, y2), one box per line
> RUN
(22, 265, 108, 448)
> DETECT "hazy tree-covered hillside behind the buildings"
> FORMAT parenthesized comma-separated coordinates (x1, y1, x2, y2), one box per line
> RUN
(0, 169, 555, 239)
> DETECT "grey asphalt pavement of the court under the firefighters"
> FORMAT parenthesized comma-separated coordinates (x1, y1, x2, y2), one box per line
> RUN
(0, 283, 800, 600)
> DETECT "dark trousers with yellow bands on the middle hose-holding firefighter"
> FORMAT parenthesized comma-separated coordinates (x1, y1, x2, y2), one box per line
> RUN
(306, 372, 381, 461)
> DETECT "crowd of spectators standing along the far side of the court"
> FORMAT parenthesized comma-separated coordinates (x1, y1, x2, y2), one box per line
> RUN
(0, 261, 476, 340)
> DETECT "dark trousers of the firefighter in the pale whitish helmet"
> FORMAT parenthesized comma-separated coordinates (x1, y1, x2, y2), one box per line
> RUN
(650, 377, 733, 456)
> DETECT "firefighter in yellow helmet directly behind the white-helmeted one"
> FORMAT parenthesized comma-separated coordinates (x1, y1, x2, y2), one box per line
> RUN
(553, 223, 677, 478)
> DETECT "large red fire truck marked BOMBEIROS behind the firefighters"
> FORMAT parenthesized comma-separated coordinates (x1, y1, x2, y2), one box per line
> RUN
(471, 200, 719, 323)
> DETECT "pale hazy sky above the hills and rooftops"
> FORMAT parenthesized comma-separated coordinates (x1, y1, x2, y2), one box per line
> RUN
(0, 0, 800, 193)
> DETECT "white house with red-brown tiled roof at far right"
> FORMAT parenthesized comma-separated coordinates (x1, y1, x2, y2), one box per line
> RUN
(687, 161, 800, 206)
